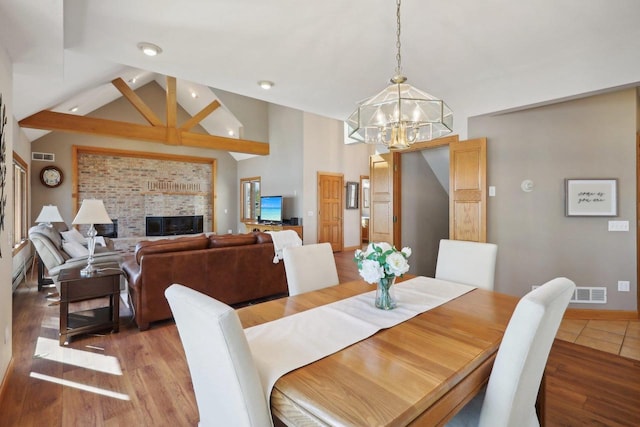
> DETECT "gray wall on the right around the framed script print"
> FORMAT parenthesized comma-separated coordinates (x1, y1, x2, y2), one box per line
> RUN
(469, 89, 637, 310)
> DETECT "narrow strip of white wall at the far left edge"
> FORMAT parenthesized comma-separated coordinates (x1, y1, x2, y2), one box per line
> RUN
(0, 41, 13, 383)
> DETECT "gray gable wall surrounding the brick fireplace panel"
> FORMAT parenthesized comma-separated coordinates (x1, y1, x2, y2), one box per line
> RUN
(31, 82, 240, 233)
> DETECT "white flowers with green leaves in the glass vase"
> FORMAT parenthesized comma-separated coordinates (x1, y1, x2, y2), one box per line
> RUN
(353, 242, 411, 283)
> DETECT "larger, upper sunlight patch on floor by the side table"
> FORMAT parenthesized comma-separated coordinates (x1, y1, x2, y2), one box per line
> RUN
(33, 337, 122, 375)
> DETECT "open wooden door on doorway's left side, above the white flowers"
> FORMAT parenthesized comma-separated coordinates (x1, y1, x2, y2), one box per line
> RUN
(369, 153, 400, 247)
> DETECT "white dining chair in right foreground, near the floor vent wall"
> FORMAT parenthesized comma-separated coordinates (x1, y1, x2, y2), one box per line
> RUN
(447, 277, 575, 427)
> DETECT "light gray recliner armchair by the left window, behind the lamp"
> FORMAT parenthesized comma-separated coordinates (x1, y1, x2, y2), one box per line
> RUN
(29, 224, 123, 292)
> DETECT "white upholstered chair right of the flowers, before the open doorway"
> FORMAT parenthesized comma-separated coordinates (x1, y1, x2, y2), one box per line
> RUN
(435, 239, 498, 290)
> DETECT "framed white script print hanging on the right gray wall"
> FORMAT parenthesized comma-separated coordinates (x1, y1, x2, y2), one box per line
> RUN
(565, 179, 618, 216)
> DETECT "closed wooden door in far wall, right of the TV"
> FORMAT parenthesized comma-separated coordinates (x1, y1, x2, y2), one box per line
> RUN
(318, 172, 344, 252)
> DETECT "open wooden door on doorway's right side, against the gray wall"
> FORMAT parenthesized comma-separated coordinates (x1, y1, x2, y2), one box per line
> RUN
(449, 138, 487, 242)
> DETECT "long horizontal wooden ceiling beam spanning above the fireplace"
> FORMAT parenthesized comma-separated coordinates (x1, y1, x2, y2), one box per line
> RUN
(19, 110, 269, 155)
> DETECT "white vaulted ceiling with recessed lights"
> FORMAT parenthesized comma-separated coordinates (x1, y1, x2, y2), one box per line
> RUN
(0, 0, 640, 149)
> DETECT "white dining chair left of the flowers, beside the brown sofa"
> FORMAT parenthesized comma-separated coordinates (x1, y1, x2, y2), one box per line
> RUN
(282, 243, 340, 296)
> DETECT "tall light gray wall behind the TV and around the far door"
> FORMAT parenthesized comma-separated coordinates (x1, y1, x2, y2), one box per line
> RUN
(238, 104, 372, 247)
